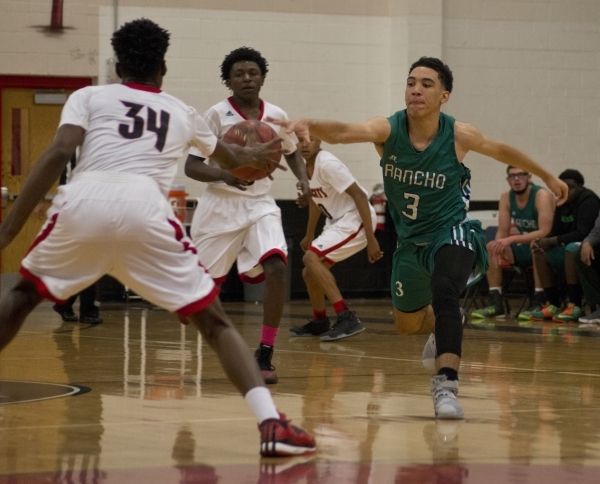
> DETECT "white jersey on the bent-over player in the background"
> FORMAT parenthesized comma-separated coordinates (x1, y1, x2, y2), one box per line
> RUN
(309, 150, 368, 224)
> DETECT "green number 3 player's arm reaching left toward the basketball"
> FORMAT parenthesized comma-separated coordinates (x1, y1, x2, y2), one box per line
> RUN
(267, 116, 392, 144)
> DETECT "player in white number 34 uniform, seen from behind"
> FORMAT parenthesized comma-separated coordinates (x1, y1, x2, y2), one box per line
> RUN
(0, 19, 315, 456)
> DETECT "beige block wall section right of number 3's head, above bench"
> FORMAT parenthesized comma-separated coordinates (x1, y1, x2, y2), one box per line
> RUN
(443, 0, 600, 199)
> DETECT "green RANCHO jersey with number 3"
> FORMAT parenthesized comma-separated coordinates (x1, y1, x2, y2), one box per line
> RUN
(380, 110, 471, 244)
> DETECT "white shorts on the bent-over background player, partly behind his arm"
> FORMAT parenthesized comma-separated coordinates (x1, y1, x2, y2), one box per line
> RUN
(309, 207, 377, 264)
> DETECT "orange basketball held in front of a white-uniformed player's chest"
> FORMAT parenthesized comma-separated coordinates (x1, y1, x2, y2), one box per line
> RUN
(223, 119, 281, 181)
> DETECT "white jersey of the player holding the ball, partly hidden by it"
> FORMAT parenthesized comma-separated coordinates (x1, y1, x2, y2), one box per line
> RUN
(190, 97, 298, 196)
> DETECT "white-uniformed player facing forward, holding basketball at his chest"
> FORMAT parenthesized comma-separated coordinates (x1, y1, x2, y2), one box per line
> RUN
(185, 47, 310, 383)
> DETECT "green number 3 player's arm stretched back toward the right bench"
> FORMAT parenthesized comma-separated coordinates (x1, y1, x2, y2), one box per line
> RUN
(454, 121, 569, 205)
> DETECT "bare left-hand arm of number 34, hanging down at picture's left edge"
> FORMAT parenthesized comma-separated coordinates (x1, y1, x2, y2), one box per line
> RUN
(0, 124, 85, 250)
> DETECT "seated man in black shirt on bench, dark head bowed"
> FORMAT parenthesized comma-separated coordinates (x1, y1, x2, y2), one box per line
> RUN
(529, 169, 600, 323)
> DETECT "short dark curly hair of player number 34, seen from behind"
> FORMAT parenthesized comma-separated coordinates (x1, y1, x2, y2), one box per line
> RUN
(110, 18, 171, 79)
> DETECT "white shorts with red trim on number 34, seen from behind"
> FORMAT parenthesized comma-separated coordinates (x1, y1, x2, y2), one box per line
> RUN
(21, 172, 218, 316)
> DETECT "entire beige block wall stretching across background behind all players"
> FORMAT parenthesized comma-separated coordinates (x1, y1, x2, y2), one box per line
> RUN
(0, 0, 600, 200)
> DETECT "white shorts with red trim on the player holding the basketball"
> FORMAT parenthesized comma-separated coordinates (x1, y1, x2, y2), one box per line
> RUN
(190, 189, 287, 283)
